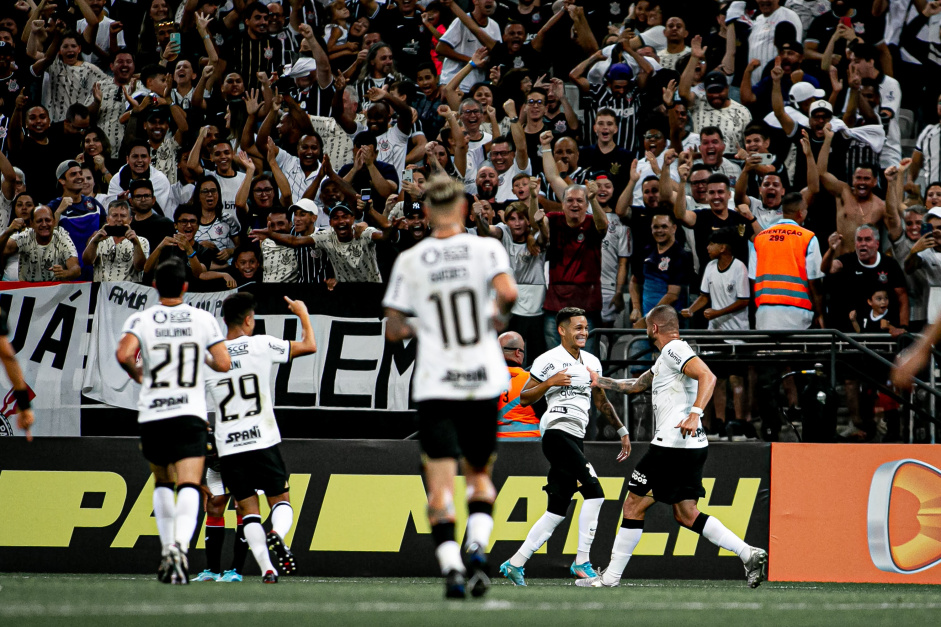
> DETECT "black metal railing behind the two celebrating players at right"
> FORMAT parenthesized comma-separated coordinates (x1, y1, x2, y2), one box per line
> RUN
(591, 328, 941, 442)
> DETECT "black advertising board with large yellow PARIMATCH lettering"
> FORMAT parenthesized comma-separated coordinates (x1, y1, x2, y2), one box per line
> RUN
(0, 437, 770, 579)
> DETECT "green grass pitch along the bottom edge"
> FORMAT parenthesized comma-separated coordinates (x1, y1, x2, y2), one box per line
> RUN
(0, 573, 941, 627)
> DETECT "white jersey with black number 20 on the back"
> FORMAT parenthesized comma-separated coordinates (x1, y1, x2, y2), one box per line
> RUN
(122, 304, 223, 423)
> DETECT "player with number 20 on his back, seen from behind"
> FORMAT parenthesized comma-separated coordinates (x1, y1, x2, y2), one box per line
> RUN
(117, 258, 229, 584)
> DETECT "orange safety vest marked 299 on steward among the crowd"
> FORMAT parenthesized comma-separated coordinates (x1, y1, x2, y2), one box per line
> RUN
(755, 220, 814, 311)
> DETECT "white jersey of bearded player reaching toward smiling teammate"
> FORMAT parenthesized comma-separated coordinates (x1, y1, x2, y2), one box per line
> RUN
(651, 340, 709, 448)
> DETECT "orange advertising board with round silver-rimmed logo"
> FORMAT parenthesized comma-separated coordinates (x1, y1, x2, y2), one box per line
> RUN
(769, 443, 941, 584)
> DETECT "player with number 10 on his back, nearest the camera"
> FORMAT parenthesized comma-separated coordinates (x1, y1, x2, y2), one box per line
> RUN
(383, 175, 517, 598)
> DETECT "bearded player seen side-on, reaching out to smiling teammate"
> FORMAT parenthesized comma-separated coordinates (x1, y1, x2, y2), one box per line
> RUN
(575, 305, 768, 588)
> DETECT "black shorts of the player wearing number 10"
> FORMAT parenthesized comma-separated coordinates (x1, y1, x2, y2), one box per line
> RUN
(418, 398, 497, 468)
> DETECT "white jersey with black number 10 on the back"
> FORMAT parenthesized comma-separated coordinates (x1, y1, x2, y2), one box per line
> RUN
(382, 233, 513, 401)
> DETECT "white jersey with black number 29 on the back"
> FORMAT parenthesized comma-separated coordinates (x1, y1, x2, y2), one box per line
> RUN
(206, 335, 291, 457)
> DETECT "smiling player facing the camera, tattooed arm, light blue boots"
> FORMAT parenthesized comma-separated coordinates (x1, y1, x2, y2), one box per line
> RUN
(500, 307, 631, 586)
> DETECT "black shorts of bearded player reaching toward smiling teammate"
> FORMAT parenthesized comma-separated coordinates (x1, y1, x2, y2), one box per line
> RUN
(627, 445, 709, 503)
